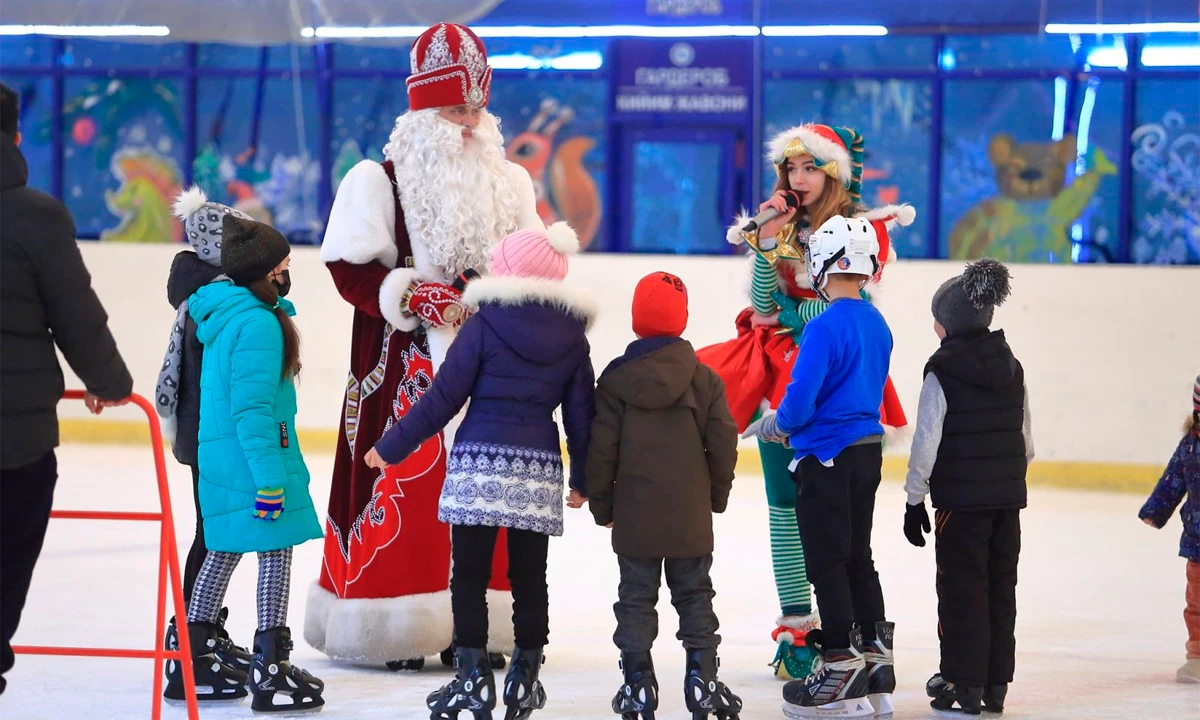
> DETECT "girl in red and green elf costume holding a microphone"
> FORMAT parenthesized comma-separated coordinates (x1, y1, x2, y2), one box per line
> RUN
(697, 125, 917, 679)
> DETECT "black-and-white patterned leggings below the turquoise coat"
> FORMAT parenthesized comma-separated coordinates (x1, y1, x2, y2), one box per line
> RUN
(187, 547, 292, 632)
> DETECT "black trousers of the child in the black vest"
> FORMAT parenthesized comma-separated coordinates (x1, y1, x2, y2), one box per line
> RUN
(935, 510, 1021, 688)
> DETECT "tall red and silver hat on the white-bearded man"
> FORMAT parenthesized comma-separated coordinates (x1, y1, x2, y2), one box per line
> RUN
(408, 23, 492, 110)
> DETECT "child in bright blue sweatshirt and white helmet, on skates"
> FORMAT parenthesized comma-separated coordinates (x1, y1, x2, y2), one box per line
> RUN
(746, 216, 895, 718)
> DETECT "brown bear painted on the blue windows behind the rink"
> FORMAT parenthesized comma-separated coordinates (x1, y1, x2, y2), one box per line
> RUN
(949, 133, 1117, 263)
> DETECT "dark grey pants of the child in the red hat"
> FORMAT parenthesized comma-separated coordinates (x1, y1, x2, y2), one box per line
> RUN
(612, 554, 721, 653)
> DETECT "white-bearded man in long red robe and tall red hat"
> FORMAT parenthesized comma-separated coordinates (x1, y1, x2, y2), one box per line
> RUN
(305, 23, 544, 670)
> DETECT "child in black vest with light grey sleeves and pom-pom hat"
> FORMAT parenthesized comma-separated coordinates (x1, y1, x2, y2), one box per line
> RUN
(904, 258, 1033, 715)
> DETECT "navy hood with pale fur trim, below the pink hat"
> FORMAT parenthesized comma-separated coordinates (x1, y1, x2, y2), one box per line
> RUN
(463, 277, 598, 365)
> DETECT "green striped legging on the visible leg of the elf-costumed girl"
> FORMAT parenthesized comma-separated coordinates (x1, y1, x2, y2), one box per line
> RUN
(758, 440, 812, 617)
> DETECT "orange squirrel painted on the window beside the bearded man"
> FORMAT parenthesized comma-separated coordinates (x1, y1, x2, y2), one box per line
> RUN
(508, 97, 600, 248)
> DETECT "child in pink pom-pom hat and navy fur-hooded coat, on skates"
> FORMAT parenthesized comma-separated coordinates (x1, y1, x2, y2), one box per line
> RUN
(366, 223, 595, 716)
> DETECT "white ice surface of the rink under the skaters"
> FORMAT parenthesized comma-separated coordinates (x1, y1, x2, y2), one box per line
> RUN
(0, 445, 1200, 720)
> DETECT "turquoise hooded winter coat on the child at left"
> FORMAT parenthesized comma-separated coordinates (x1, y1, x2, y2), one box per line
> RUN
(188, 282, 322, 553)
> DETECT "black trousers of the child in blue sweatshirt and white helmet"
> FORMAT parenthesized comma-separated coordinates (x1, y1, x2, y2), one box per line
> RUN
(793, 443, 884, 649)
